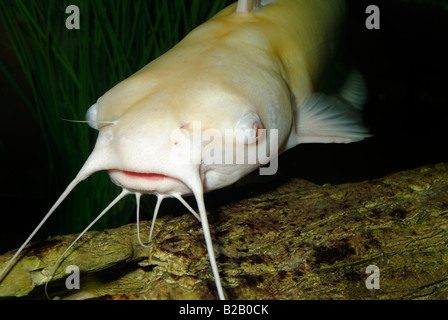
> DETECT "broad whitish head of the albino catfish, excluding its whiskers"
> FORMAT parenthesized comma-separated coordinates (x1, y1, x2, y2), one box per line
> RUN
(87, 82, 272, 195)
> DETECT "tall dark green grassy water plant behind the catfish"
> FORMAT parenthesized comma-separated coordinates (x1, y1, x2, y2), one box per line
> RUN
(0, 0, 232, 233)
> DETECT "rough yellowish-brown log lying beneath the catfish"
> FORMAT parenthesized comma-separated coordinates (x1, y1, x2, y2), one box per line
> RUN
(0, 163, 448, 299)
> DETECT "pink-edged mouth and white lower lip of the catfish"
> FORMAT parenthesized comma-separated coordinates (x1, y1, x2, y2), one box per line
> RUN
(108, 169, 191, 194)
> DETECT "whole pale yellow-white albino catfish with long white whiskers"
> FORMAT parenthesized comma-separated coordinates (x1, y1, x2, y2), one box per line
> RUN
(0, 0, 369, 299)
